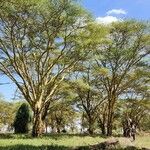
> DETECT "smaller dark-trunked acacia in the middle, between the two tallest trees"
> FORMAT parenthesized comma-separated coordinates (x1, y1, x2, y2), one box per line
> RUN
(73, 65, 104, 134)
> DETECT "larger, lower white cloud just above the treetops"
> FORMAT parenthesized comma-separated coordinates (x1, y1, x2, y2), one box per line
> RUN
(96, 16, 122, 24)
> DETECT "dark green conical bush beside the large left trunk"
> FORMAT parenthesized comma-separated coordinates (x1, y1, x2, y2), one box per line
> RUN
(13, 103, 31, 133)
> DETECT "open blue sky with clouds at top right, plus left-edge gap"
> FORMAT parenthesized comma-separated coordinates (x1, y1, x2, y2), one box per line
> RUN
(0, 0, 150, 100)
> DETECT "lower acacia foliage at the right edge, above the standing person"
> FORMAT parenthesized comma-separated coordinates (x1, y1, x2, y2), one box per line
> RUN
(120, 66, 150, 130)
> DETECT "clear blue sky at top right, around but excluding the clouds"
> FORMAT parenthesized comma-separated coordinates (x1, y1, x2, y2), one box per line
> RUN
(81, 0, 150, 20)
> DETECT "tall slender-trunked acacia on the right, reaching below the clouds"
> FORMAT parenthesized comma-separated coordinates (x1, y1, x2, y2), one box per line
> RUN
(94, 21, 150, 135)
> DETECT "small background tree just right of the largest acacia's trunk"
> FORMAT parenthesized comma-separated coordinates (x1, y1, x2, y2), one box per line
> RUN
(47, 80, 77, 133)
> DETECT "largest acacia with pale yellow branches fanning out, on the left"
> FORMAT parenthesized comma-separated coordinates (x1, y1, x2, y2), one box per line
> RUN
(0, 0, 91, 136)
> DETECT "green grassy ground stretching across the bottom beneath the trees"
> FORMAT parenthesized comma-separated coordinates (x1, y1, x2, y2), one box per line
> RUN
(0, 135, 150, 150)
